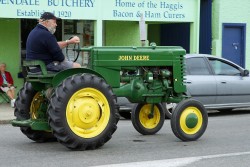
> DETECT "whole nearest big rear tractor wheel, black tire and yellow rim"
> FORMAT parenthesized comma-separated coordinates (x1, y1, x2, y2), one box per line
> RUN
(48, 74, 119, 150)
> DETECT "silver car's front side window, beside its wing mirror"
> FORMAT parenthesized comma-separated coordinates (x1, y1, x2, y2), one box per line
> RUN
(209, 59, 240, 75)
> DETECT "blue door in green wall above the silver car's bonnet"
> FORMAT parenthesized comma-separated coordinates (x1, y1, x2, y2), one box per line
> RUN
(222, 24, 246, 67)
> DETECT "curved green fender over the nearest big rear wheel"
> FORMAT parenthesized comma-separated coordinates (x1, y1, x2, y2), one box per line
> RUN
(52, 68, 105, 88)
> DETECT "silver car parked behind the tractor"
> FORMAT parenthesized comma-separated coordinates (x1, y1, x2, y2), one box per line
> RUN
(118, 54, 250, 118)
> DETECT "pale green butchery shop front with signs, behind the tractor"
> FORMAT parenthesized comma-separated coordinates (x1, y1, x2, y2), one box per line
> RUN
(0, 0, 200, 101)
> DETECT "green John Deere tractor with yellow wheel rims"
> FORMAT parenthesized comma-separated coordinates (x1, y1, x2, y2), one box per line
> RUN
(12, 45, 208, 150)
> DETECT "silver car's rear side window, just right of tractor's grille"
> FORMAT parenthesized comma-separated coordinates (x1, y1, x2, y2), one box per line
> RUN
(186, 57, 210, 75)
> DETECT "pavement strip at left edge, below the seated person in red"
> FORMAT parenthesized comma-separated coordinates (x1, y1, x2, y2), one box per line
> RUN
(0, 103, 15, 124)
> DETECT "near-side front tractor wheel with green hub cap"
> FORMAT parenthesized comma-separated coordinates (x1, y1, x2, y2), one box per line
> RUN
(171, 99, 208, 141)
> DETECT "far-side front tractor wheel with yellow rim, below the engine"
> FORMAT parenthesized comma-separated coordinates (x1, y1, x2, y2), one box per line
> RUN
(131, 103, 165, 135)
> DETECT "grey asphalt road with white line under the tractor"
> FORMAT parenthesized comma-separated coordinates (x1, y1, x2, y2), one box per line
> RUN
(0, 110, 250, 167)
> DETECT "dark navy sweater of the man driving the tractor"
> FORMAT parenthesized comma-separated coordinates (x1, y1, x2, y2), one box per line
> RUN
(26, 24, 64, 65)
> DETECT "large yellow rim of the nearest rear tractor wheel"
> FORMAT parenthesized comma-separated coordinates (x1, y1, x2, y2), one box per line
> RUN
(66, 88, 110, 138)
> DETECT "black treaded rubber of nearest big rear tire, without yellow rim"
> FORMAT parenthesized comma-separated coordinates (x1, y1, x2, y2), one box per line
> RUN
(48, 74, 120, 150)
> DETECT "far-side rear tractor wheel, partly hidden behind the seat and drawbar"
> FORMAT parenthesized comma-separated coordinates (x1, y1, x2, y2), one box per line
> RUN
(14, 82, 56, 143)
